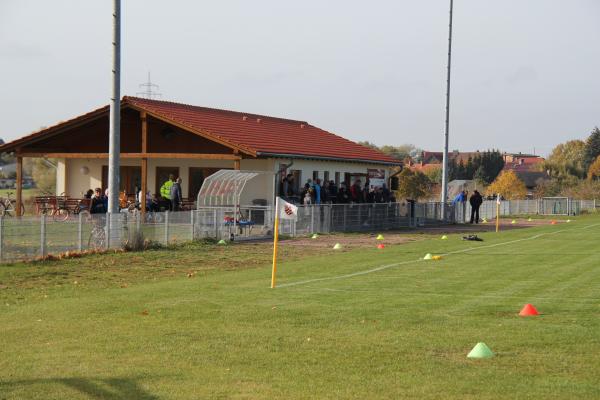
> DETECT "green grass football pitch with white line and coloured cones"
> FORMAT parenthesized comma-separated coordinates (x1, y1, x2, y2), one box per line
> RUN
(0, 216, 600, 399)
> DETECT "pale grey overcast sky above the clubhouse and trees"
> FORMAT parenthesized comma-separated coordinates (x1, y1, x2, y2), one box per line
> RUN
(0, 0, 600, 155)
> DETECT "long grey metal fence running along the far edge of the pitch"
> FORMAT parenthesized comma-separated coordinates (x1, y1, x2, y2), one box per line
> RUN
(0, 200, 600, 262)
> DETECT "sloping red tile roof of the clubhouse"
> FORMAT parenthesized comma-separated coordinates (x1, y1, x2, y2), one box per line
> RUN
(123, 96, 401, 164)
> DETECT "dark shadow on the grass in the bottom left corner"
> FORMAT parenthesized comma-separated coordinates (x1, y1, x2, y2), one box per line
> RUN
(0, 377, 158, 400)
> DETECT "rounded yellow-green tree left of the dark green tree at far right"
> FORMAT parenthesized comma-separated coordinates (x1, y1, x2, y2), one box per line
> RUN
(542, 140, 586, 178)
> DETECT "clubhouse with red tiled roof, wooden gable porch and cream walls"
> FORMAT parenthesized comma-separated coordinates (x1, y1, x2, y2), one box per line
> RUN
(0, 96, 400, 212)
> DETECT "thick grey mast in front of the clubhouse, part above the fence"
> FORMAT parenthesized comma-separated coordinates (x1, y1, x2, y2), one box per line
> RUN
(108, 0, 121, 213)
